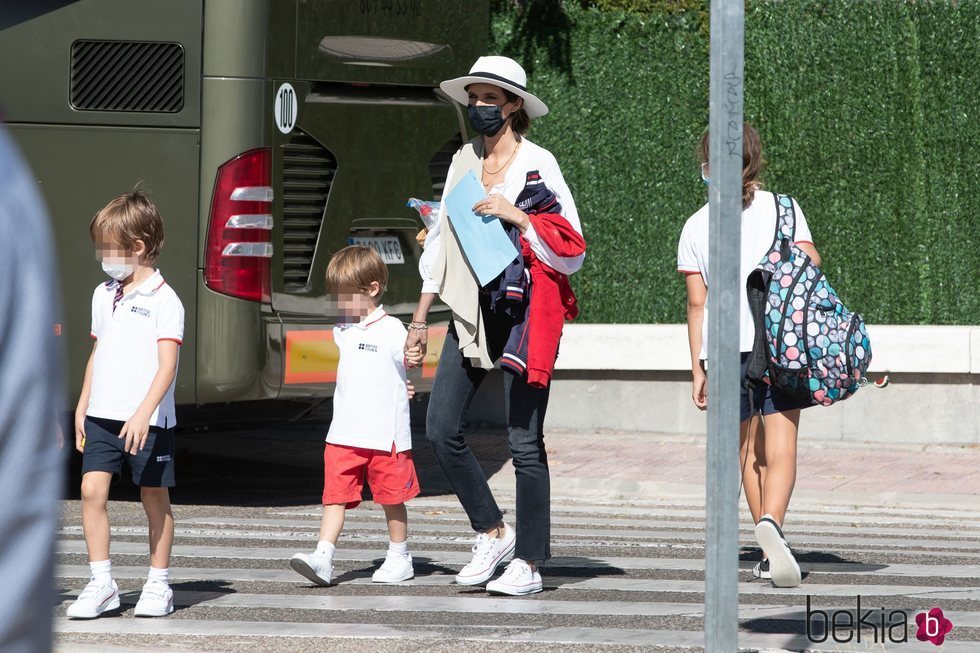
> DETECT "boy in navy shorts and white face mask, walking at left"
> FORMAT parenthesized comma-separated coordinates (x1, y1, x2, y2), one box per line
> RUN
(68, 190, 184, 619)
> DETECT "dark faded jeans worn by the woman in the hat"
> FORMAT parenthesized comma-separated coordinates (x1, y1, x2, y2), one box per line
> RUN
(426, 300, 551, 562)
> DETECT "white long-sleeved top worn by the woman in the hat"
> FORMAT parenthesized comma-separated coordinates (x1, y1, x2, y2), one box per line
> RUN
(419, 138, 585, 293)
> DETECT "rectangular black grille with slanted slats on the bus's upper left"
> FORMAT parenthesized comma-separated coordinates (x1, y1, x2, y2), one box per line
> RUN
(69, 41, 184, 113)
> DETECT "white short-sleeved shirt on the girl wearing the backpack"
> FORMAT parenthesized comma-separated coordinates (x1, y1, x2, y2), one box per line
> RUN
(677, 190, 813, 359)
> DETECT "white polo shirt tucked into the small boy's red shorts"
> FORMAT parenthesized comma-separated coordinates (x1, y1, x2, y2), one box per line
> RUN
(327, 306, 412, 452)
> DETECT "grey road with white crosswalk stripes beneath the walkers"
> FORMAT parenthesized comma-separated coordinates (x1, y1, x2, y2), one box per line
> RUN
(55, 427, 980, 653)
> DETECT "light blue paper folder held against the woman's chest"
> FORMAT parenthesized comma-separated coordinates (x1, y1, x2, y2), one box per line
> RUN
(445, 171, 519, 288)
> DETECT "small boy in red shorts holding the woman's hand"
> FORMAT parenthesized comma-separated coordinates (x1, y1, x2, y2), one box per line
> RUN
(289, 245, 422, 586)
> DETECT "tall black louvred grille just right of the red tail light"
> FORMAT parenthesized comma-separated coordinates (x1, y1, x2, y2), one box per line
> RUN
(282, 129, 337, 292)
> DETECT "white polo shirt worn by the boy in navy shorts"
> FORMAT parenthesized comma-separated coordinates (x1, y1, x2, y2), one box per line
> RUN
(86, 270, 184, 428)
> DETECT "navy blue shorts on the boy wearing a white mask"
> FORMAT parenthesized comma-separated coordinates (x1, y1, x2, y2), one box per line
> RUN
(82, 417, 175, 487)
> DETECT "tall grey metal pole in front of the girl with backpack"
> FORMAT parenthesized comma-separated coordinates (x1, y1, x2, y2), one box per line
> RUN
(704, 0, 745, 653)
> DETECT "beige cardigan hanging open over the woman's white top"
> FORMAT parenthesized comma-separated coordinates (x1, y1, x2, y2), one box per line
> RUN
(432, 137, 493, 370)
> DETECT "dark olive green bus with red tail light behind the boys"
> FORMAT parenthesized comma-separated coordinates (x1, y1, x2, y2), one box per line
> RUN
(0, 0, 489, 412)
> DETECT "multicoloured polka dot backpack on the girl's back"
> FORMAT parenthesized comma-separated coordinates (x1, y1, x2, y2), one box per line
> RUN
(746, 195, 871, 406)
